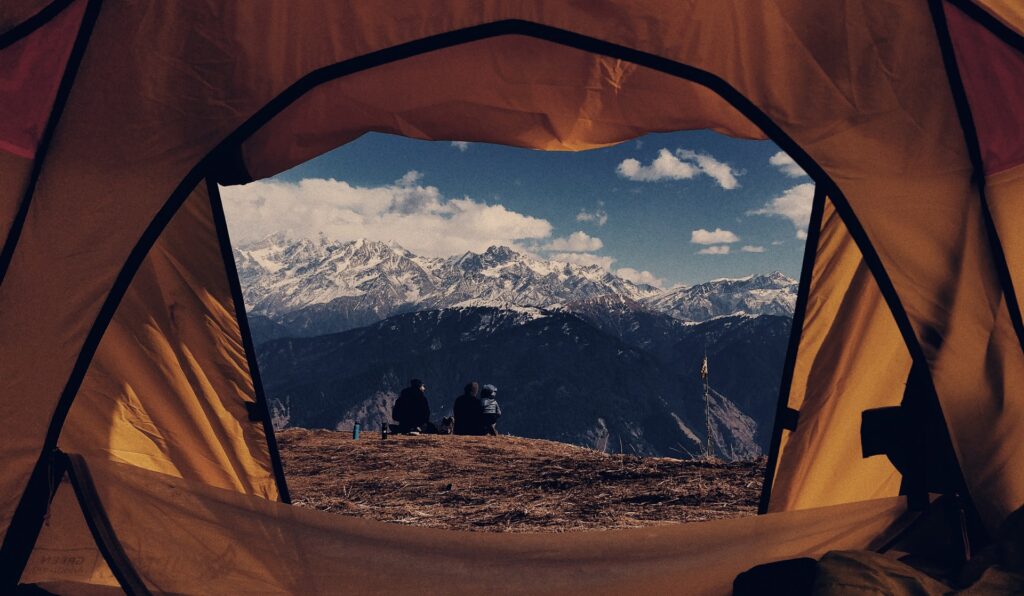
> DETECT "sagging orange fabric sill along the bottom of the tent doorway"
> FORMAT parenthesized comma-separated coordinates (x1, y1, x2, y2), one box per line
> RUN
(18, 454, 913, 594)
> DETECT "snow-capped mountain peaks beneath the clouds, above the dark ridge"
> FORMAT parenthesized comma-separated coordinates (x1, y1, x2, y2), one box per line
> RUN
(234, 233, 797, 340)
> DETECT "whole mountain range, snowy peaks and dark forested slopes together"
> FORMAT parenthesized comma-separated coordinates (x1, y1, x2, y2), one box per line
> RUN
(234, 235, 797, 459)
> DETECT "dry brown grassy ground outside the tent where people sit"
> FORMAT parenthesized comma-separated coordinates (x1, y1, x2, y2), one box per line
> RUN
(278, 429, 765, 531)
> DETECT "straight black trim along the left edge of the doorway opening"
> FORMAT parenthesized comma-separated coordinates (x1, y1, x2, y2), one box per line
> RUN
(206, 178, 292, 503)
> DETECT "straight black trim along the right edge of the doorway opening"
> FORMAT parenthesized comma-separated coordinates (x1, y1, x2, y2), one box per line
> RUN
(758, 184, 827, 513)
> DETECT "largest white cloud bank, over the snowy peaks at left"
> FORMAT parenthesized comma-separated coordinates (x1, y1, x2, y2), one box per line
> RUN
(221, 171, 552, 256)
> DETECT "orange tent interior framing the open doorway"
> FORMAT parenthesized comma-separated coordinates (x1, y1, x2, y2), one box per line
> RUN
(0, 0, 1024, 593)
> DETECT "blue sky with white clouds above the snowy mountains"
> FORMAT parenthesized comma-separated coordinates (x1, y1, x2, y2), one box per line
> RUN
(222, 131, 813, 287)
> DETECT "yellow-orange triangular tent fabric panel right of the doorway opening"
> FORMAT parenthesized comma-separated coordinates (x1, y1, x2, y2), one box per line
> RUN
(769, 197, 910, 511)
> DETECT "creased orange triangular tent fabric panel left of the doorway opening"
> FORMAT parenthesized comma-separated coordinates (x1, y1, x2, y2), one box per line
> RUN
(57, 185, 282, 500)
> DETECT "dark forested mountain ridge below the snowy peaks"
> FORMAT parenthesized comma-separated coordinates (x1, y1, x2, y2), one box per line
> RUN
(259, 307, 790, 459)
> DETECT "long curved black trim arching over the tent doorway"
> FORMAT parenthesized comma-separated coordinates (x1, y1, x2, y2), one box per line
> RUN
(0, 17, 946, 586)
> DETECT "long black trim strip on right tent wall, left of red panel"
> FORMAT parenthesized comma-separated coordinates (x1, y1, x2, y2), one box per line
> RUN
(929, 0, 1024, 350)
